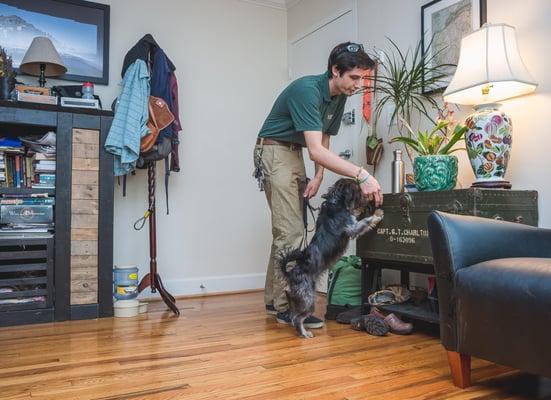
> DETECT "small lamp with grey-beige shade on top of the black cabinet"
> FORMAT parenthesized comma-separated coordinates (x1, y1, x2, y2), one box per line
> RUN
(19, 36, 67, 87)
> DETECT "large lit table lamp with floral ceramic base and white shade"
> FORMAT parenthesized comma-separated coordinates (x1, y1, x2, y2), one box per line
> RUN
(444, 24, 537, 189)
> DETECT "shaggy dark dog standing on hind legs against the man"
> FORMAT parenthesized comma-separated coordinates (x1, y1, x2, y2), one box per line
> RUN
(278, 178, 383, 338)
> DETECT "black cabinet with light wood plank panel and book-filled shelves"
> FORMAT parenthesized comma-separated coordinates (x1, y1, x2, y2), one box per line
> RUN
(0, 101, 114, 326)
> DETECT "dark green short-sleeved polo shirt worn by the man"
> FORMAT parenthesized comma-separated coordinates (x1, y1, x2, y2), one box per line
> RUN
(258, 74, 346, 146)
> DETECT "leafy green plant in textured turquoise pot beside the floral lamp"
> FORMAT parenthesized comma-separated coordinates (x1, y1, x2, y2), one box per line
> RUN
(391, 114, 468, 191)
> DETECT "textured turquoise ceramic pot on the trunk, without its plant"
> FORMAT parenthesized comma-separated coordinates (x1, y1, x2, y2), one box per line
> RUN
(413, 154, 457, 191)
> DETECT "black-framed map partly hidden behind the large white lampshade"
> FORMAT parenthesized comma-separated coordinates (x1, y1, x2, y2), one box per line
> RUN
(421, 0, 487, 95)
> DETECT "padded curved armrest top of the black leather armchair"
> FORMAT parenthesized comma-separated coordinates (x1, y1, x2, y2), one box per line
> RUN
(428, 211, 551, 276)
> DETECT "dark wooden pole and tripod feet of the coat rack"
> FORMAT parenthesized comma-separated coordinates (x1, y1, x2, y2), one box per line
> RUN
(138, 161, 180, 316)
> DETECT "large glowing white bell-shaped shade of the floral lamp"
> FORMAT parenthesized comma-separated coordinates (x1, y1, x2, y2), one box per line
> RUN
(444, 24, 537, 105)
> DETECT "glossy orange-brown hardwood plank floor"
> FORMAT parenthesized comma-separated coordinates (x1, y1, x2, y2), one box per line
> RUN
(0, 292, 544, 400)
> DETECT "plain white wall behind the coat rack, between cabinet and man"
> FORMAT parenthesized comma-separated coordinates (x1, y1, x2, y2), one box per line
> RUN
(17, 0, 287, 295)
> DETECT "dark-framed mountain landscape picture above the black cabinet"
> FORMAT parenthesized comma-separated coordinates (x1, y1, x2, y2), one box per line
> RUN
(0, 0, 110, 85)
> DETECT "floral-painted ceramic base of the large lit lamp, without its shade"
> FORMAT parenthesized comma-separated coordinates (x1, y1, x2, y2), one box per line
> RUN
(465, 104, 513, 186)
